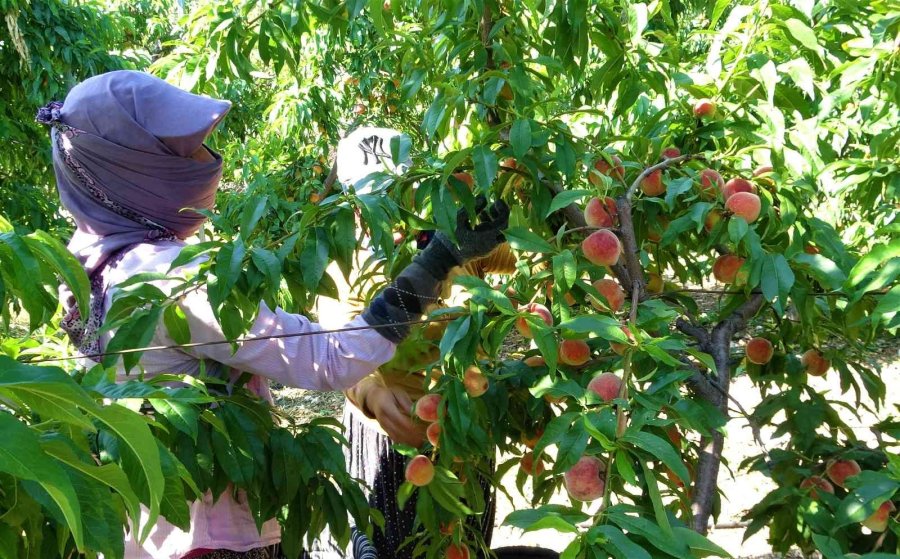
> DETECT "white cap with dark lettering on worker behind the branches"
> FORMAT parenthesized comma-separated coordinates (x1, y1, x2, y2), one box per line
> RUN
(337, 126, 412, 194)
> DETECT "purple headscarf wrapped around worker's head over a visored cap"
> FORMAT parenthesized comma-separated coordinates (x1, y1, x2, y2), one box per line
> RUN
(37, 70, 231, 352)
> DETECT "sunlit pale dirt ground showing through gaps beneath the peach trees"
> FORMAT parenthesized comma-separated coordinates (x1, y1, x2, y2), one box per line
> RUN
(275, 330, 900, 558)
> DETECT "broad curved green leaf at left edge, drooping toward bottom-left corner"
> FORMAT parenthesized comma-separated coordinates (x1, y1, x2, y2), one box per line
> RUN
(0, 413, 84, 549)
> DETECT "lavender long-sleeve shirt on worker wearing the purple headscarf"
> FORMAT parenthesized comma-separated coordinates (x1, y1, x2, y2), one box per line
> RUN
(104, 242, 395, 559)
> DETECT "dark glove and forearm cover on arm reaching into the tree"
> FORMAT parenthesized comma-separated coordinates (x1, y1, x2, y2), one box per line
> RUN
(362, 196, 509, 343)
